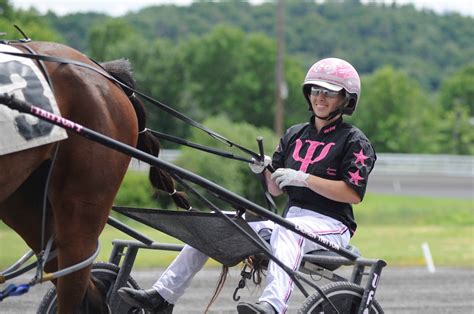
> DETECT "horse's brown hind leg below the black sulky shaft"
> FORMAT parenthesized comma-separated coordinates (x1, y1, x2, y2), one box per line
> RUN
(51, 144, 134, 313)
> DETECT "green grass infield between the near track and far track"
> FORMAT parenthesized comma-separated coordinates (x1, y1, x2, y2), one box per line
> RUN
(0, 195, 474, 269)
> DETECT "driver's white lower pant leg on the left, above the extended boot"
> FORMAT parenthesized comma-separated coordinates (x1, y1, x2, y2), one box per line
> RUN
(153, 245, 209, 304)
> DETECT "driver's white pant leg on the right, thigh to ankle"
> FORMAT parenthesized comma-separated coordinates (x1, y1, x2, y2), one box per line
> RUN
(260, 209, 349, 313)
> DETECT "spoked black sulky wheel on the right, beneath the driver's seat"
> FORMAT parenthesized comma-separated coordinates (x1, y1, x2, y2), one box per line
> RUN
(298, 282, 383, 314)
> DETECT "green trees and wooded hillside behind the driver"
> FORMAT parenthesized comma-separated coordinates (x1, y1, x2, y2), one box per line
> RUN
(0, 0, 474, 154)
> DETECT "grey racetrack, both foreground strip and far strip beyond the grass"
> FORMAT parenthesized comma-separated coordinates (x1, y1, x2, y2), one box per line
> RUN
(0, 173, 474, 314)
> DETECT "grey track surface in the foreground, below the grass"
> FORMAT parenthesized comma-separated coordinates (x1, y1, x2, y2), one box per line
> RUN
(0, 266, 474, 314)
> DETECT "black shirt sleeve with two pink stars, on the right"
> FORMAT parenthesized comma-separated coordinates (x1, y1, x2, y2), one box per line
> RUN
(341, 136, 377, 200)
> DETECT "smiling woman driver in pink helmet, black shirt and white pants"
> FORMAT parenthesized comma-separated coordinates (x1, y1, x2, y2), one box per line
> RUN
(119, 58, 376, 313)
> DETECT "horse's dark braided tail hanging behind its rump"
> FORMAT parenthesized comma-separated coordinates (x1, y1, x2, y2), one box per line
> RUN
(101, 59, 190, 209)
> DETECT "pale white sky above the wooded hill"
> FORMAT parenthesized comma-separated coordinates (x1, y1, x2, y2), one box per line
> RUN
(10, 0, 474, 17)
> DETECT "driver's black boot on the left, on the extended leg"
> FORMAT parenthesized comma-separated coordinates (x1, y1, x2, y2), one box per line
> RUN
(117, 287, 174, 314)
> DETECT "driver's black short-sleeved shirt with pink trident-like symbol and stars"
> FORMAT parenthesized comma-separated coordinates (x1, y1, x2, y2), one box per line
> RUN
(272, 116, 377, 235)
